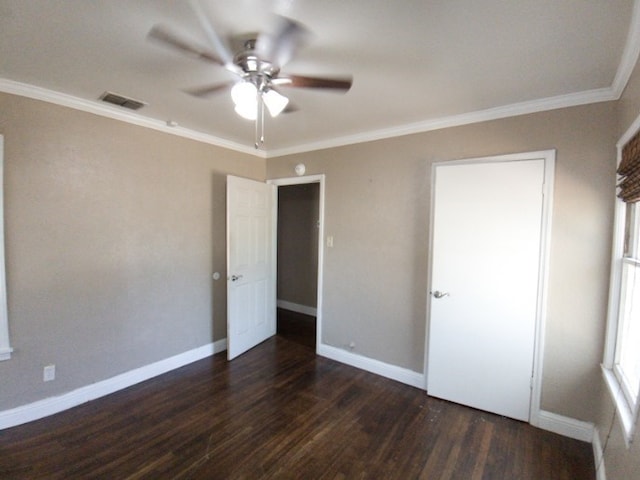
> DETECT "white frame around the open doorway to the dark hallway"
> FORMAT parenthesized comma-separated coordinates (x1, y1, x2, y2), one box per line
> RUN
(267, 174, 325, 354)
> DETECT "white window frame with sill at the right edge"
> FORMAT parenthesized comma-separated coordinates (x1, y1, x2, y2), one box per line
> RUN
(602, 116, 640, 447)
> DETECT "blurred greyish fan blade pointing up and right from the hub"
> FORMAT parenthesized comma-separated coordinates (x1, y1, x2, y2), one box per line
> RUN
(256, 15, 309, 67)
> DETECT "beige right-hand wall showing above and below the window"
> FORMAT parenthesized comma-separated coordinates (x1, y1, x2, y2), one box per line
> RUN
(595, 58, 640, 480)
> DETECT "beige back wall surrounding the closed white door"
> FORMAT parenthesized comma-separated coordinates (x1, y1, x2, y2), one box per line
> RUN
(267, 102, 616, 421)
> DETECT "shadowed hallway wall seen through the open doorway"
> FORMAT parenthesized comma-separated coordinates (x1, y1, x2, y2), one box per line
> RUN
(277, 183, 320, 308)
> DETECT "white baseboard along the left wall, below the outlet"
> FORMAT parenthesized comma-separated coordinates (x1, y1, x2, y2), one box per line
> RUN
(0, 338, 227, 430)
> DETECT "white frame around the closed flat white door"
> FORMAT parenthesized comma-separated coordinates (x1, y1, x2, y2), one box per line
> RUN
(424, 150, 556, 426)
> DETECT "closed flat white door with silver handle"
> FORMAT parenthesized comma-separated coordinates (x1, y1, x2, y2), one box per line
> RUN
(427, 159, 545, 420)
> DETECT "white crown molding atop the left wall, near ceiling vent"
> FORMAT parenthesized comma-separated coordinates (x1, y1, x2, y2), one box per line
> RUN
(0, 78, 266, 158)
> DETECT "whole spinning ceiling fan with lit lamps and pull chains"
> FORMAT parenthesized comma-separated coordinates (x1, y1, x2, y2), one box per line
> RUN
(148, 0, 353, 149)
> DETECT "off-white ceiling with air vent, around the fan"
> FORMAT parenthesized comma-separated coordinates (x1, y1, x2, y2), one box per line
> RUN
(0, 0, 640, 155)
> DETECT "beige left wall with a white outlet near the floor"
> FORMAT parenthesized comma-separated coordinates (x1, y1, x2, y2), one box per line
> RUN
(0, 94, 265, 410)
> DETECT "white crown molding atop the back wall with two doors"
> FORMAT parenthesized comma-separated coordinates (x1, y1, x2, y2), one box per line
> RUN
(266, 87, 616, 158)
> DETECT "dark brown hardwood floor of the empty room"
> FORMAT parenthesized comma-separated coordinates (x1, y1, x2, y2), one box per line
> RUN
(0, 326, 595, 480)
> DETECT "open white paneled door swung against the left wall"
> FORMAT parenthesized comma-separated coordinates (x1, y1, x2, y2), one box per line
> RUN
(227, 176, 276, 360)
